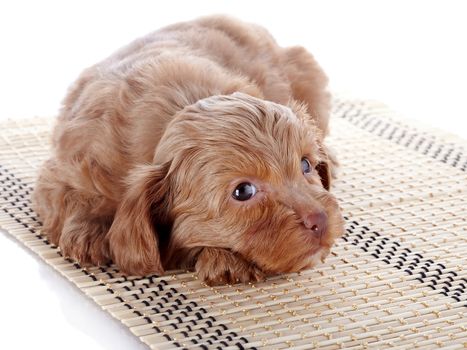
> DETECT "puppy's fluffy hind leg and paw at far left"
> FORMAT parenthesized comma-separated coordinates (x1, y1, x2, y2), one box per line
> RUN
(33, 160, 113, 265)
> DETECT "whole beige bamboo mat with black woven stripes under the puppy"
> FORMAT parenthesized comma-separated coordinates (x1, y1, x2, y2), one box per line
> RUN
(0, 99, 467, 349)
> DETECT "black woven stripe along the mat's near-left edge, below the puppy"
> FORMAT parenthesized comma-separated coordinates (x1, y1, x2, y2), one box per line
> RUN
(0, 165, 249, 348)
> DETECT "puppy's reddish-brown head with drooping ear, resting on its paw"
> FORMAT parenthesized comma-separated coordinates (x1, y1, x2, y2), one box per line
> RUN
(108, 93, 343, 274)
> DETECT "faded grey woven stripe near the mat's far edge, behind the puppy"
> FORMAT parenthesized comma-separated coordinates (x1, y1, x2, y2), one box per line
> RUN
(333, 101, 467, 171)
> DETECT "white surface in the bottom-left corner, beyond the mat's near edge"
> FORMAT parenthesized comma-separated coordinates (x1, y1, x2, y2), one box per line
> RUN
(0, 230, 147, 350)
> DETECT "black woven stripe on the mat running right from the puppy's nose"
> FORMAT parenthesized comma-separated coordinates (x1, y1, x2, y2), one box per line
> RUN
(342, 217, 467, 307)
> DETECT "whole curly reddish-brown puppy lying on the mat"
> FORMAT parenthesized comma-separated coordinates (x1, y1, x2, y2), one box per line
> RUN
(33, 16, 343, 285)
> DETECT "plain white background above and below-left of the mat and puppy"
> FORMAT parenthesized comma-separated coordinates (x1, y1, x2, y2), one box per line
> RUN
(0, 0, 467, 349)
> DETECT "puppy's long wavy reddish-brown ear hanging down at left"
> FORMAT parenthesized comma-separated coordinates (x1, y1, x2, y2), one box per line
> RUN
(106, 164, 170, 275)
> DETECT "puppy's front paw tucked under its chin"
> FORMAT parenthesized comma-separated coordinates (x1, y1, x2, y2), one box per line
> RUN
(195, 248, 265, 286)
